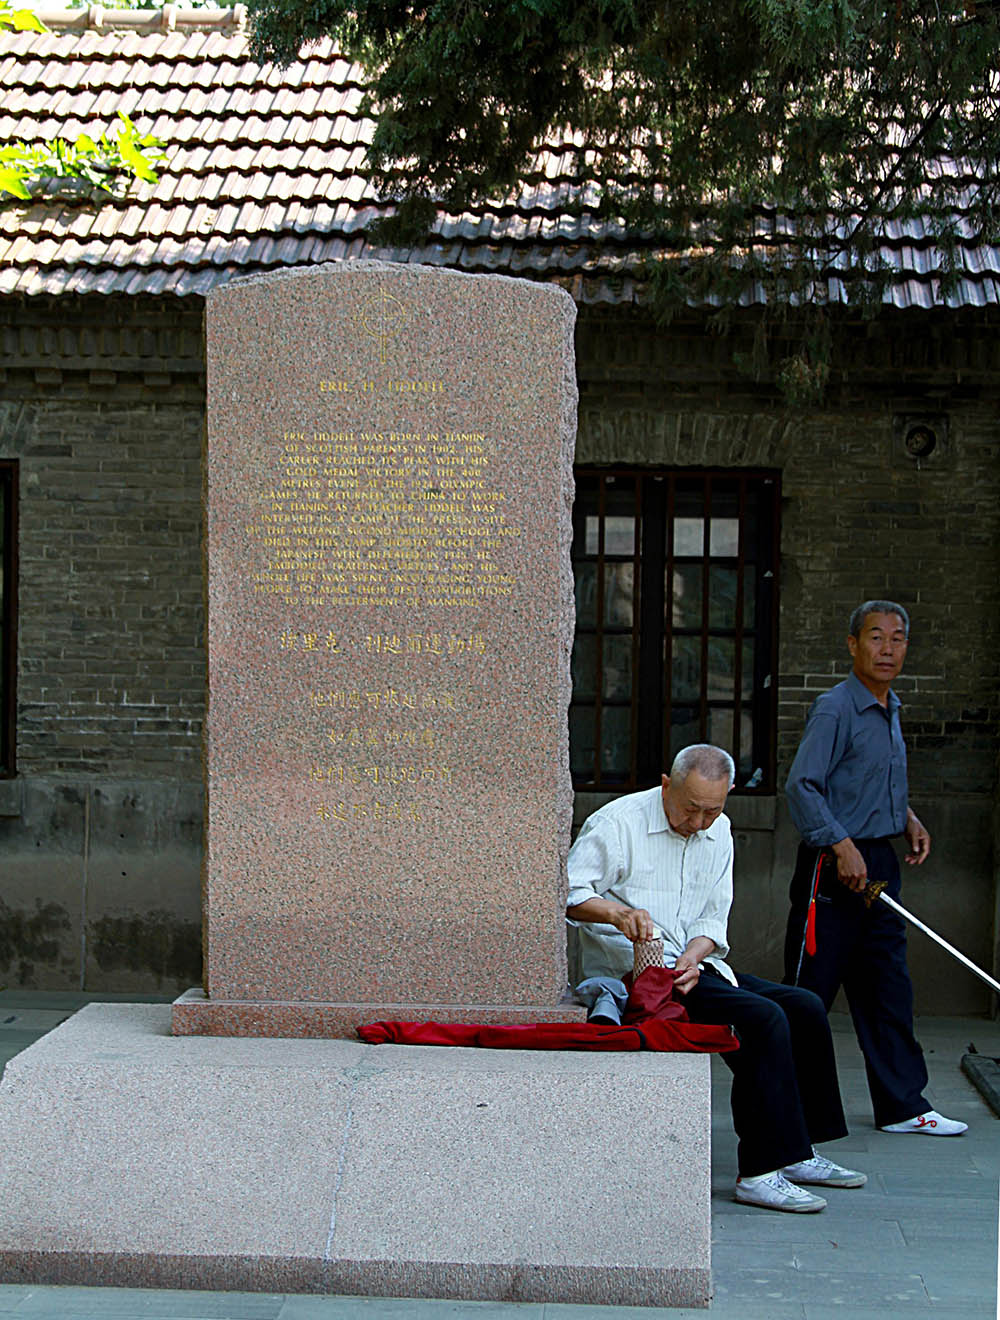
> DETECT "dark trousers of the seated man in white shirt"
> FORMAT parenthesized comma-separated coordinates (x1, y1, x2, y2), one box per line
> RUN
(683, 970, 847, 1177)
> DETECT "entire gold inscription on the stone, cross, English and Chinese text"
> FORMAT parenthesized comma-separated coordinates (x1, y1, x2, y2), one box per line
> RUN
(237, 320, 522, 829)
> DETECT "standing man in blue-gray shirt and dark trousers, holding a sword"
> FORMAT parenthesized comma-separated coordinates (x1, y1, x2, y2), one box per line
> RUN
(785, 601, 968, 1137)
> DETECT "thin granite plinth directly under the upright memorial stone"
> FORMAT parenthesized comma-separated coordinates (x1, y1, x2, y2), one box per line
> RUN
(170, 990, 587, 1040)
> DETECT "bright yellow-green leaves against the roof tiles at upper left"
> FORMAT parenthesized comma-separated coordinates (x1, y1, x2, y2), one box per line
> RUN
(0, 0, 165, 201)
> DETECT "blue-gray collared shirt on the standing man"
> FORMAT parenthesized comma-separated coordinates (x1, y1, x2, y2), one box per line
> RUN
(785, 673, 908, 847)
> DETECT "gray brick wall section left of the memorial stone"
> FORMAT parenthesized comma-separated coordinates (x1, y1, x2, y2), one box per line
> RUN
(0, 297, 204, 993)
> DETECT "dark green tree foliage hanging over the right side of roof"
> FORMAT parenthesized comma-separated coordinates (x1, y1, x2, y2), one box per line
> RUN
(249, 0, 1000, 396)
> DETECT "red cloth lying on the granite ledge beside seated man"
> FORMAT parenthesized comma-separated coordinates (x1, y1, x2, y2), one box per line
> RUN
(358, 968, 739, 1053)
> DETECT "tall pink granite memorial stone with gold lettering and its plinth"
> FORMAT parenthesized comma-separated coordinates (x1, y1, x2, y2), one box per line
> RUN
(173, 261, 582, 1035)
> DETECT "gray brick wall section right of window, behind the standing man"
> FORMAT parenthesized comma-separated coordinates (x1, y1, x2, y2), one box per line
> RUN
(780, 411, 1000, 797)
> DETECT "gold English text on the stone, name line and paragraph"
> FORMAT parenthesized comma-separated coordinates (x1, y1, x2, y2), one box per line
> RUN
(247, 422, 521, 609)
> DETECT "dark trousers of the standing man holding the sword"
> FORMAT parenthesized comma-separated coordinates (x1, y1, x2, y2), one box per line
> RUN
(785, 838, 930, 1127)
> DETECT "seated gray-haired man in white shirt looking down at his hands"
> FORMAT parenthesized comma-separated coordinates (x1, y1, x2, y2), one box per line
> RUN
(566, 744, 867, 1212)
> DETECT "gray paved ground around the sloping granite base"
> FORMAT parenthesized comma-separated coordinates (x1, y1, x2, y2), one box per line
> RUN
(0, 991, 1000, 1320)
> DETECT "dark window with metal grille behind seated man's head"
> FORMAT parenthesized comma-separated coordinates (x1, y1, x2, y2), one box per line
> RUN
(570, 467, 780, 793)
